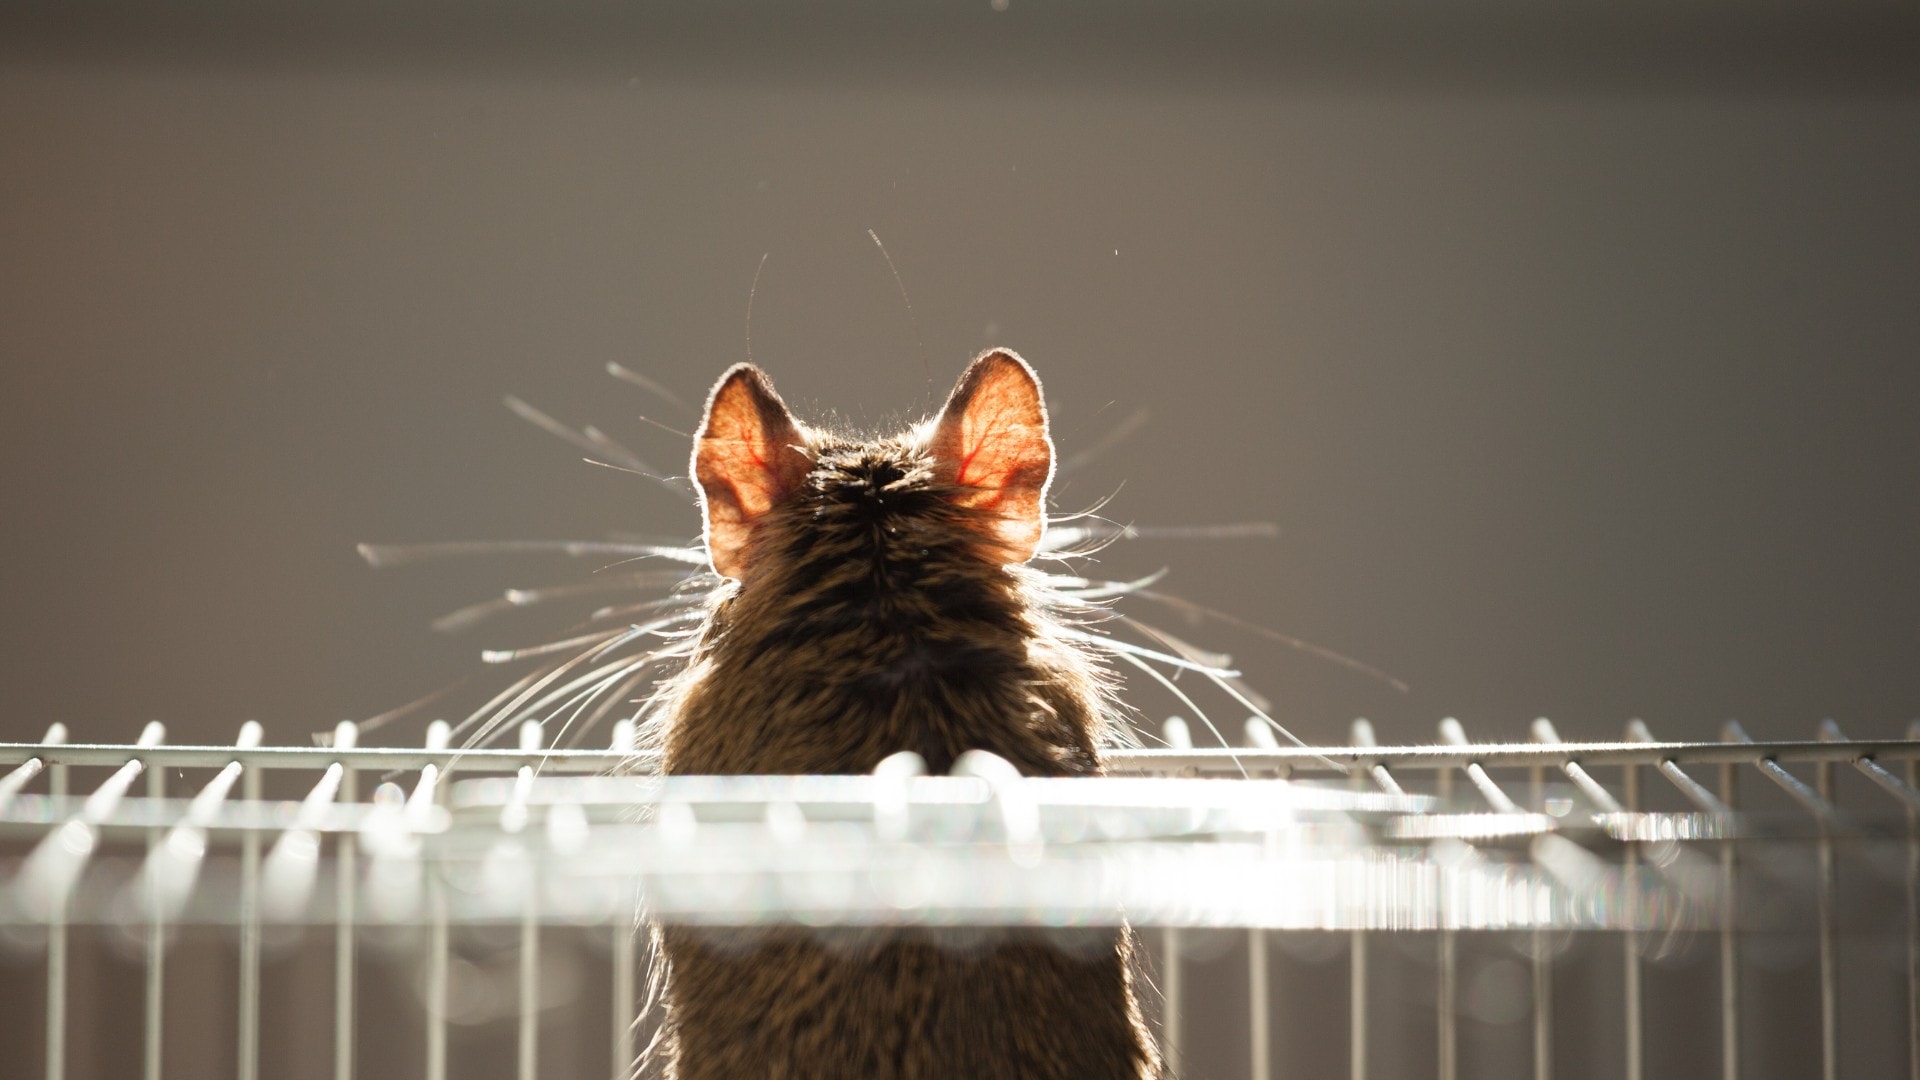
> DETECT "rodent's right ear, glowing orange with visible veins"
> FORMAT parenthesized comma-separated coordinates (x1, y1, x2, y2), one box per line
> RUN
(927, 350, 1054, 563)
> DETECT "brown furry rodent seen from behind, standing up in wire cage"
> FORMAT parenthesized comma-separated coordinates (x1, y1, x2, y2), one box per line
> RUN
(655, 350, 1165, 1080)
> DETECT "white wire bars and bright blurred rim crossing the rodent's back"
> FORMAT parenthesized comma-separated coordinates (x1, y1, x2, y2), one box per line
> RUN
(0, 721, 1920, 1080)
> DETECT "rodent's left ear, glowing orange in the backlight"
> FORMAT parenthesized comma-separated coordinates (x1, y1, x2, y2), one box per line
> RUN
(693, 363, 814, 580)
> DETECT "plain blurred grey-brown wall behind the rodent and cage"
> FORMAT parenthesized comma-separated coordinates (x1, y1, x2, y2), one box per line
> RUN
(0, 0, 1920, 1076)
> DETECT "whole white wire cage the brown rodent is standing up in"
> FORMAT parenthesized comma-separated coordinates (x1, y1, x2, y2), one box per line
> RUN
(0, 719, 1920, 1080)
